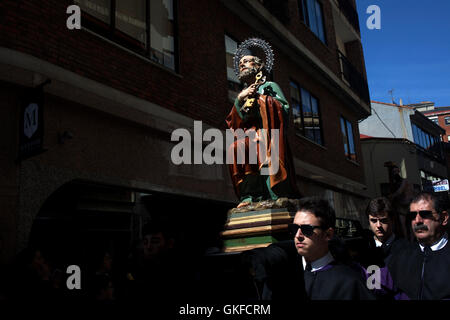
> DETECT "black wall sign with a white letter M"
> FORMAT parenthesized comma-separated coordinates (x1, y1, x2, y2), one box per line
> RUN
(18, 85, 44, 161)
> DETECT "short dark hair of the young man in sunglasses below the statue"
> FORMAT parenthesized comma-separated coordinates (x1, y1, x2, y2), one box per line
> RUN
(296, 197, 336, 229)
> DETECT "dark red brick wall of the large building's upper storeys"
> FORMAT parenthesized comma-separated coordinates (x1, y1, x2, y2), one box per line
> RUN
(0, 0, 363, 185)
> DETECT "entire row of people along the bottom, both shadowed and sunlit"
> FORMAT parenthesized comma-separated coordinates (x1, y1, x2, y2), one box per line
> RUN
(0, 192, 450, 302)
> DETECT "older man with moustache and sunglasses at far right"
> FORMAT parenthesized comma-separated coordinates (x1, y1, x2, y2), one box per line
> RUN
(389, 192, 450, 300)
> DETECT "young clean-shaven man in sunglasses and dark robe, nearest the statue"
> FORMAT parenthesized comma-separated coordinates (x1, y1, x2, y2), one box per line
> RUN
(247, 198, 374, 301)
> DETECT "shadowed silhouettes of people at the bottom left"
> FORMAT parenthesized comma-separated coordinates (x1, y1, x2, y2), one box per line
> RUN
(0, 224, 194, 301)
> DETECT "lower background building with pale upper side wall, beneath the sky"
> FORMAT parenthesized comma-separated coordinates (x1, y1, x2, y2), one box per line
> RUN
(359, 101, 448, 197)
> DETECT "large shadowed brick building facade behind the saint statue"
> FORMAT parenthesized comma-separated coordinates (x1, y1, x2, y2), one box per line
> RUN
(0, 0, 370, 262)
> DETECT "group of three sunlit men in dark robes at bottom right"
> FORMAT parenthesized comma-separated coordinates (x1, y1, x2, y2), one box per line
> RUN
(245, 192, 450, 300)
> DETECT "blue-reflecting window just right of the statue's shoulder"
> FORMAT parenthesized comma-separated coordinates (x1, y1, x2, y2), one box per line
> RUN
(290, 81, 323, 145)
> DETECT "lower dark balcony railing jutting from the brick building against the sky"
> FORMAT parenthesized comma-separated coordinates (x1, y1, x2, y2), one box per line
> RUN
(337, 50, 370, 105)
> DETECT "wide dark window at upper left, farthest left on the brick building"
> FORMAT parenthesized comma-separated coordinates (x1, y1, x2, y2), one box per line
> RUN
(75, 0, 176, 70)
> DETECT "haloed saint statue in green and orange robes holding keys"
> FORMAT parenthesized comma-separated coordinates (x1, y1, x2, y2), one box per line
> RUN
(226, 38, 299, 208)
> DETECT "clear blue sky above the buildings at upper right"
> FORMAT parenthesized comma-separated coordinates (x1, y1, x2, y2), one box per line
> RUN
(356, 0, 450, 107)
